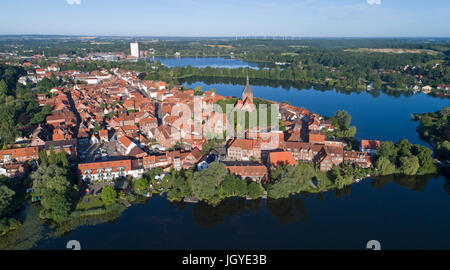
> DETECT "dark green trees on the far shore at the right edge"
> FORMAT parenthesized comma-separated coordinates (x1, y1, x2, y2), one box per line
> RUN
(413, 107, 450, 160)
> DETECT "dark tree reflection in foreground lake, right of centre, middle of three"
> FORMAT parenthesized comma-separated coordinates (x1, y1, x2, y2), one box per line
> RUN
(267, 195, 309, 224)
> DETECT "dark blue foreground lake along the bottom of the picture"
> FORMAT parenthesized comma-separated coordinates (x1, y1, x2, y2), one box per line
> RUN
(37, 176, 450, 249)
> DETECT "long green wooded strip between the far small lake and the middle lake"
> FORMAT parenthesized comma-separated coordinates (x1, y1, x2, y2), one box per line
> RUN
(145, 64, 450, 91)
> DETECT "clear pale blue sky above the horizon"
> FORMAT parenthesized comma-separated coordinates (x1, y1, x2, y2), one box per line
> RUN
(0, 0, 450, 37)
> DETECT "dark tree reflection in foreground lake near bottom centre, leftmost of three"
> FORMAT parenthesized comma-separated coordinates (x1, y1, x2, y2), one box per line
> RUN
(192, 198, 260, 227)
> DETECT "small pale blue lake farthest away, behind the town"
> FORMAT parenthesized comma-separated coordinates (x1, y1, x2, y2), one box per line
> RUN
(154, 57, 258, 68)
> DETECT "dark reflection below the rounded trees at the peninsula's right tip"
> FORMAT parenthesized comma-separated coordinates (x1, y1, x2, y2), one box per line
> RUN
(372, 174, 445, 191)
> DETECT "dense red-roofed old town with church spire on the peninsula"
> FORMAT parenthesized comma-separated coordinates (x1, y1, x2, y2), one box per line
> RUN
(0, 43, 380, 189)
